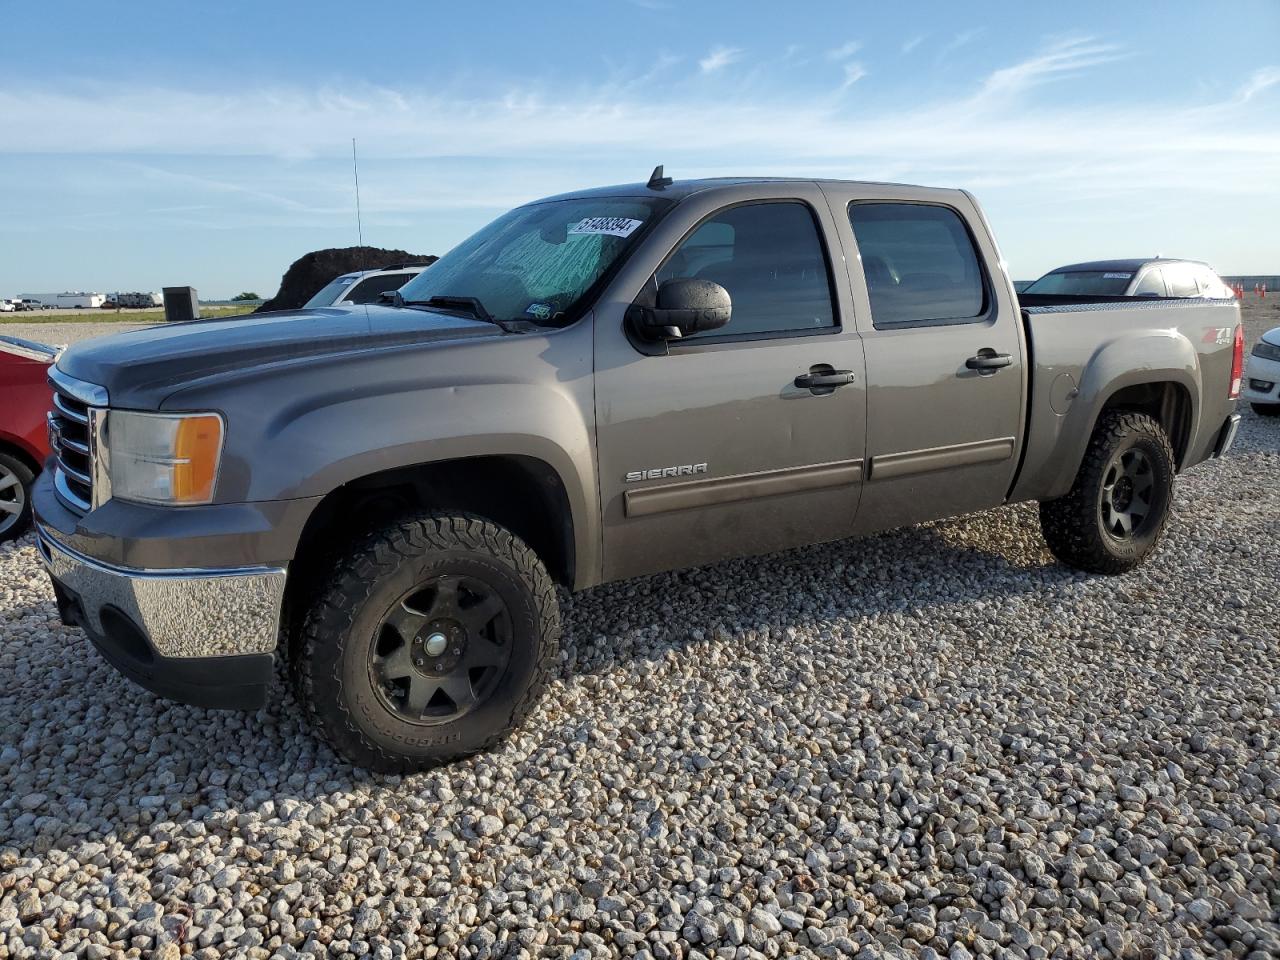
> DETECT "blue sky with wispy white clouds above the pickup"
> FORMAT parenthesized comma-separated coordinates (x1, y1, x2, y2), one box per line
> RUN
(0, 0, 1280, 298)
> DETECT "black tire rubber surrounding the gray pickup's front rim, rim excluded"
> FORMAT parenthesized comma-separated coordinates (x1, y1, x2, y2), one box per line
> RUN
(302, 512, 561, 773)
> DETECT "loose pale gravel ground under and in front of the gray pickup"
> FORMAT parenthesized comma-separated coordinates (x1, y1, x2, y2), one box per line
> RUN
(0, 304, 1280, 960)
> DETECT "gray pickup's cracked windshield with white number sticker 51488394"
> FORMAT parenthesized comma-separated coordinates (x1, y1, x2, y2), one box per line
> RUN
(401, 197, 671, 325)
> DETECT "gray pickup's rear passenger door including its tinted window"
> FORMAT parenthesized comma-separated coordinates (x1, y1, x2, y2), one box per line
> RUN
(824, 184, 1027, 532)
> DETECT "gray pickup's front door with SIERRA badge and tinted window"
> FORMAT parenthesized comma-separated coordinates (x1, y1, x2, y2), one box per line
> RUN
(595, 184, 865, 580)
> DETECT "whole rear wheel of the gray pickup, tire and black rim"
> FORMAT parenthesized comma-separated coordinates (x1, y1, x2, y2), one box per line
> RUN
(1041, 411, 1174, 573)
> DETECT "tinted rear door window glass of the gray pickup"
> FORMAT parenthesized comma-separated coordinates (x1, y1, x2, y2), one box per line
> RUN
(849, 202, 987, 326)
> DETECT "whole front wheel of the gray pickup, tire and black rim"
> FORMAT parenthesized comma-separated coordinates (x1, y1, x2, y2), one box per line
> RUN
(302, 513, 559, 773)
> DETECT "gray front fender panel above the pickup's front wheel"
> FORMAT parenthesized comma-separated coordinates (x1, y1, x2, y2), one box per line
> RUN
(165, 323, 600, 585)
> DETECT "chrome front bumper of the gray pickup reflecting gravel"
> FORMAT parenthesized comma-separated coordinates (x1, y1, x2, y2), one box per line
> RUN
(37, 526, 285, 659)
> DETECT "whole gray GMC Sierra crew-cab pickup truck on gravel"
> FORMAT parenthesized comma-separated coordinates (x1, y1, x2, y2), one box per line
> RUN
(35, 170, 1243, 771)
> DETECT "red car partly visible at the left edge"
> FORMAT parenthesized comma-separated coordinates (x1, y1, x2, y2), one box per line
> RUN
(0, 337, 58, 541)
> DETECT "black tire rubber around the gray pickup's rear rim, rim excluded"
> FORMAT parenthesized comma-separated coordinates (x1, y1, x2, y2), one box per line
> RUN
(1039, 410, 1175, 573)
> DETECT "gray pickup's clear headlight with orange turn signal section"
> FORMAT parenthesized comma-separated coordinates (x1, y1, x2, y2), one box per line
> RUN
(106, 410, 223, 504)
